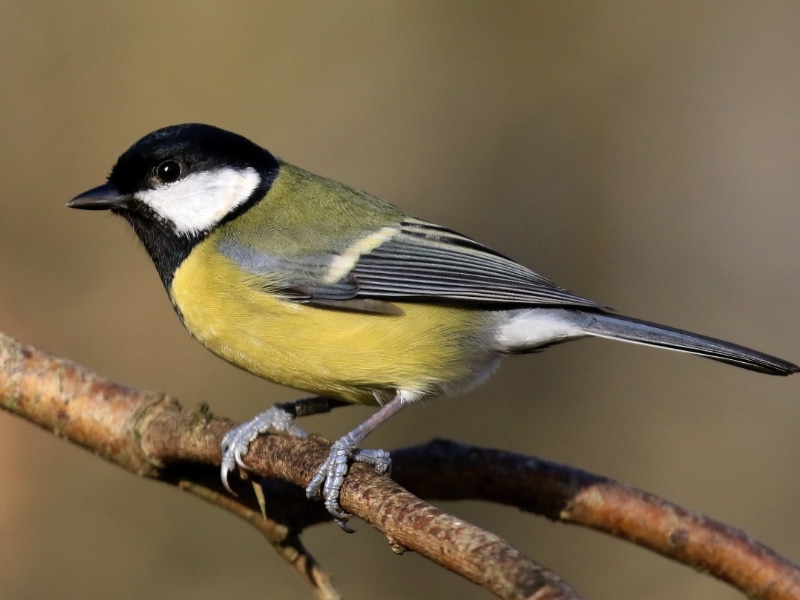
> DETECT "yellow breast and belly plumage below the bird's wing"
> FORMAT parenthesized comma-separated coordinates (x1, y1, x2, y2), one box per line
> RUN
(170, 239, 496, 404)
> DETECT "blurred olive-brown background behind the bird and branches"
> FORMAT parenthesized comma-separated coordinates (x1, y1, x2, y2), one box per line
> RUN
(0, 0, 800, 600)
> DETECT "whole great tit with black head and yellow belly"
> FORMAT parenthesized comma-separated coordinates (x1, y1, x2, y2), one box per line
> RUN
(68, 124, 800, 530)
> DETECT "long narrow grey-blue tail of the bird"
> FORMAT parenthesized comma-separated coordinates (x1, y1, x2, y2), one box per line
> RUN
(581, 312, 800, 375)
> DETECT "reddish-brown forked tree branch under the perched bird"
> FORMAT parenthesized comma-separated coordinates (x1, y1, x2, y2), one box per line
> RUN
(0, 334, 800, 600)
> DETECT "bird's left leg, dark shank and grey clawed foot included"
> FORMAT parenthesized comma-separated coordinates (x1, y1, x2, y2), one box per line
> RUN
(221, 396, 348, 493)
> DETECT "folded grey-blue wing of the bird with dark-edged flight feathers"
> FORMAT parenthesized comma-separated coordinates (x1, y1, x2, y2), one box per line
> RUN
(219, 219, 604, 313)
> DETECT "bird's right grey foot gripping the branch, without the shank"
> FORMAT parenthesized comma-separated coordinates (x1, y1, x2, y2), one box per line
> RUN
(306, 436, 392, 533)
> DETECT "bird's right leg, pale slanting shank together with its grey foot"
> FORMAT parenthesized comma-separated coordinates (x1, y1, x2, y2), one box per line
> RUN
(306, 392, 415, 533)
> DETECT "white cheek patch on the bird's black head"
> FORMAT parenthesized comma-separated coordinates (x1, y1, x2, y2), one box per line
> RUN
(134, 168, 261, 235)
